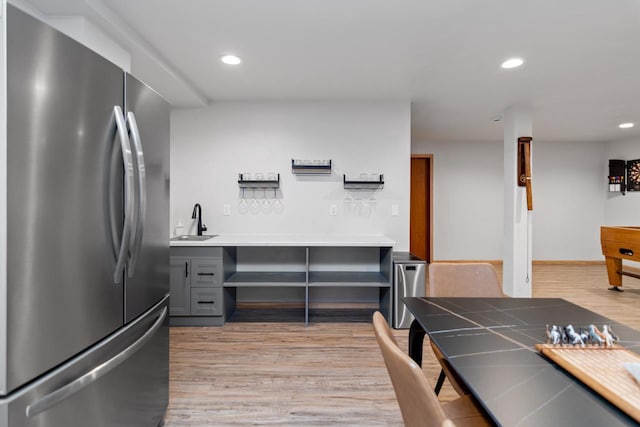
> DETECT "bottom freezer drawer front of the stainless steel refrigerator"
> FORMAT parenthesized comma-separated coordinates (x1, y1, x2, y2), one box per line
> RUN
(0, 296, 169, 427)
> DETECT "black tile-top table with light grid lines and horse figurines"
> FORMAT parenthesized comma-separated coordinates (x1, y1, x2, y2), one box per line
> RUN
(403, 298, 640, 427)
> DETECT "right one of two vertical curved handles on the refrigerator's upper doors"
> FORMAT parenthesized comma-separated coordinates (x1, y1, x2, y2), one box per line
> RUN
(127, 111, 147, 277)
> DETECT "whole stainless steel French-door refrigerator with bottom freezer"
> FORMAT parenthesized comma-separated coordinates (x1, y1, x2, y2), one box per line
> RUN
(0, 2, 170, 427)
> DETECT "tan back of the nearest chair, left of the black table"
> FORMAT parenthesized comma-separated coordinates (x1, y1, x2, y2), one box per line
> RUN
(373, 311, 451, 427)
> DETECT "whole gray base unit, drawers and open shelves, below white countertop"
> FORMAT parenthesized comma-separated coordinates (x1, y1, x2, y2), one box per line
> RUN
(170, 244, 392, 326)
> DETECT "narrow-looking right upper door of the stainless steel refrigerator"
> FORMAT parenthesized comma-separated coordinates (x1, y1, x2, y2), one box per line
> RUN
(125, 74, 170, 322)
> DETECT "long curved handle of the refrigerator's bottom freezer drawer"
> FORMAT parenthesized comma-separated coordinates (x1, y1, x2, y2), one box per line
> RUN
(26, 307, 167, 418)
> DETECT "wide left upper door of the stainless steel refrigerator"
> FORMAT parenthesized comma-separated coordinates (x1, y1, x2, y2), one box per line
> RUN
(0, 5, 124, 395)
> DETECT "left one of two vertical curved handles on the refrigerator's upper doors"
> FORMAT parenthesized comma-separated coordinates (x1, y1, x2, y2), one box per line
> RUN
(113, 105, 135, 283)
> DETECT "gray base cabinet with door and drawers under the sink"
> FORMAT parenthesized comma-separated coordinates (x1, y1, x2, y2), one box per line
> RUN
(169, 247, 225, 326)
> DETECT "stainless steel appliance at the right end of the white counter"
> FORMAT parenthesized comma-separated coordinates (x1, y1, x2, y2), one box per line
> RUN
(391, 252, 426, 329)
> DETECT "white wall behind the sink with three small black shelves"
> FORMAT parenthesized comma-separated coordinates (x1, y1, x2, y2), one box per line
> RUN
(171, 101, 410, 250)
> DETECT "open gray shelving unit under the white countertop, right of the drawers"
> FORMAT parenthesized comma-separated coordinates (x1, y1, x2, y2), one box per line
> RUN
(223, 243, 392, 324)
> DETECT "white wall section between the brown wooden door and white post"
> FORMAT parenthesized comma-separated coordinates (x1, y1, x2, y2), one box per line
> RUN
(411, 141, 504, 261)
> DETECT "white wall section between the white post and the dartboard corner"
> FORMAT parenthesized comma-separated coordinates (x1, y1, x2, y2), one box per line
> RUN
(533, 141, 608, 260)
